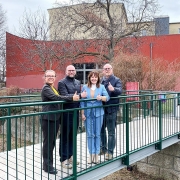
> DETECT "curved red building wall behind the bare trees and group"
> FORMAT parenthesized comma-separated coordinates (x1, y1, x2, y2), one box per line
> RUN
(6, 33, 180, 90)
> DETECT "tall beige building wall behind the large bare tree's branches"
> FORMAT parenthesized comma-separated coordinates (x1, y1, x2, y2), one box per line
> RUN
(48, 3, 128, 40)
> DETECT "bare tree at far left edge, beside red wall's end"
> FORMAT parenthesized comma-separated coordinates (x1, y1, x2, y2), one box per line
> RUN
(0, 4, 7, 82)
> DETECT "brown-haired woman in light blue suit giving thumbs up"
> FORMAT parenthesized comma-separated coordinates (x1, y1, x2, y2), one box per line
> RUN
(81, 71, 109, 164)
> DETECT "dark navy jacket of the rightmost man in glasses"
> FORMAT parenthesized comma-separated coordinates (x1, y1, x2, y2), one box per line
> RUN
(101, 75, 122, 113)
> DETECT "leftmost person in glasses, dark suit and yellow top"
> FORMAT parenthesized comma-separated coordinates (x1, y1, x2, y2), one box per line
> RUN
(41, 70, 79, 174)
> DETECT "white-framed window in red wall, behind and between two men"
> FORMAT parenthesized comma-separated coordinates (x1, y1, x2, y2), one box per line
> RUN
(73, 63, 99, 84)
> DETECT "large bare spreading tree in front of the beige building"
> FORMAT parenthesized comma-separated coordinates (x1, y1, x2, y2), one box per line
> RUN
(49, 0, 158, 61)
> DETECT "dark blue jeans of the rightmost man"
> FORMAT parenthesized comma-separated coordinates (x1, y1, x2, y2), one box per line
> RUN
(101, 111, 117, 154)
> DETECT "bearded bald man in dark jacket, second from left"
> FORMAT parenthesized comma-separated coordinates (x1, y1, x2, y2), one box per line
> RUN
(58, 65, 87, 169)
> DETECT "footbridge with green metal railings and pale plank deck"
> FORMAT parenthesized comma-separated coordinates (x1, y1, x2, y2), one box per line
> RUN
(0, 92, 180, 180)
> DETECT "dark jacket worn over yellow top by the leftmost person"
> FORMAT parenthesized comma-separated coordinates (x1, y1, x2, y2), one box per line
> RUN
(41, 84, 73, 120)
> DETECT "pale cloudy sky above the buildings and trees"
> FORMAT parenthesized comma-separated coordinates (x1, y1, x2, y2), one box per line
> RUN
(0, 0, 180, 33)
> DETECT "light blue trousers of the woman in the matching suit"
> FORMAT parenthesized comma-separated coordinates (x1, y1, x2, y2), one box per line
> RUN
(84, 114, 103, 154)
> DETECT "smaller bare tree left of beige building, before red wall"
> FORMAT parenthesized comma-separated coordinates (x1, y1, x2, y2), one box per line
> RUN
(9, 9, 70, 76)
